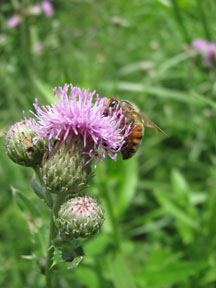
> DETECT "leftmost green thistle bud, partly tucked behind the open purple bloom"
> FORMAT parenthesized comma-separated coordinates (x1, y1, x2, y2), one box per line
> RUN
(5, 120, 47, 167)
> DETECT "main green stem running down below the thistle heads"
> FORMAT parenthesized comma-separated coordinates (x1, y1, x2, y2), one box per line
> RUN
(46, 195, 64, 288)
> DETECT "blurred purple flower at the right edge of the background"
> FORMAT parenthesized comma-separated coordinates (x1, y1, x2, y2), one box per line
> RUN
(192, 39, 216, 66)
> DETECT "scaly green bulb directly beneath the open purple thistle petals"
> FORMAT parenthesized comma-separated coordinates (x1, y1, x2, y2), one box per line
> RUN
(42, 138, 92, 194)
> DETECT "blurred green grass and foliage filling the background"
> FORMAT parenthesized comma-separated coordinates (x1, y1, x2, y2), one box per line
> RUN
(0, 0, 216, 288)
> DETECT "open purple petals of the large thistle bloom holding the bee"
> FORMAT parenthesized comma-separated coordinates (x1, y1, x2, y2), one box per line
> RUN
(30, 84, 130, 161)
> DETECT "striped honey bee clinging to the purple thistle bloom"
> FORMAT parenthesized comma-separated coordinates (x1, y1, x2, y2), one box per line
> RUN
(104, 97, 167, 160)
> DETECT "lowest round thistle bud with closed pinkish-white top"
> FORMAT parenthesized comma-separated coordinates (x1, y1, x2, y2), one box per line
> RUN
(56, 196, 104, 240)
